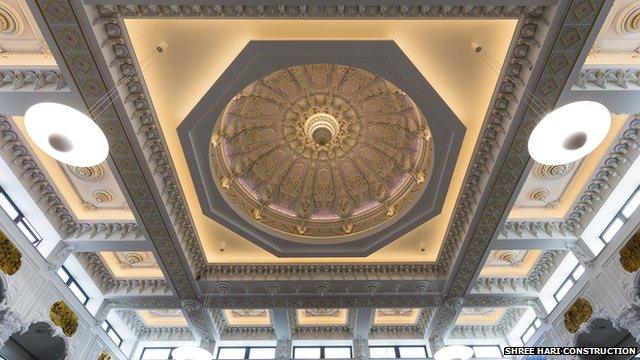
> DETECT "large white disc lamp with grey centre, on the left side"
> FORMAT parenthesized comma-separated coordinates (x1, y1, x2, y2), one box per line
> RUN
(24, 102, 109, 167)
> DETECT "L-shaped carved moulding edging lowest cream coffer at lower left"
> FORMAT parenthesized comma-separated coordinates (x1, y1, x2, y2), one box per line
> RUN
(118, 310, 194, 341)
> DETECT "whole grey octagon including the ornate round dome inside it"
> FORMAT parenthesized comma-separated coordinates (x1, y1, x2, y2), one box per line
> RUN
(178, 40, 465, 257)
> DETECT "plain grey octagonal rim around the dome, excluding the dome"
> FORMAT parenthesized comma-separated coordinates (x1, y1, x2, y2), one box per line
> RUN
(178, 40, 465, 257)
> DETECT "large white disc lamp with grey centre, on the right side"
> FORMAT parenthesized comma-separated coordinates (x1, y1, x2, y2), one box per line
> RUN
(528, 101, 611, 165)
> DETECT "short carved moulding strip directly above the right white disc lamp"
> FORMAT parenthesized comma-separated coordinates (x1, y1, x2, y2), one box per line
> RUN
(574, 68, 640, 90)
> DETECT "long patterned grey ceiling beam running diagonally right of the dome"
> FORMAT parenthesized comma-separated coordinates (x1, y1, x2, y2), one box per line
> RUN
(429, 0, 613, 348)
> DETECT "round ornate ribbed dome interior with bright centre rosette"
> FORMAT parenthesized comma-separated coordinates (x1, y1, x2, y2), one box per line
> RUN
(210, 64, 433, 240)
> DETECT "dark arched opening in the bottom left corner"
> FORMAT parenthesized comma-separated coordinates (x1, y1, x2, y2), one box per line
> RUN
(0, 322, 67, 360)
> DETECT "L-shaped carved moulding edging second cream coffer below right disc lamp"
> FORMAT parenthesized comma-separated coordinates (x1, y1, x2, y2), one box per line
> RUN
(473, 250, 568, 294)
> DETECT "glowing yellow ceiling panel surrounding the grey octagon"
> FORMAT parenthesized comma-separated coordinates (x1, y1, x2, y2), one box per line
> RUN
(124, 18, 517, 263)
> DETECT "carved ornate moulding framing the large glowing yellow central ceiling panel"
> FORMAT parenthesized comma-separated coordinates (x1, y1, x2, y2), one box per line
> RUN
(95, 5, 545, 278)
